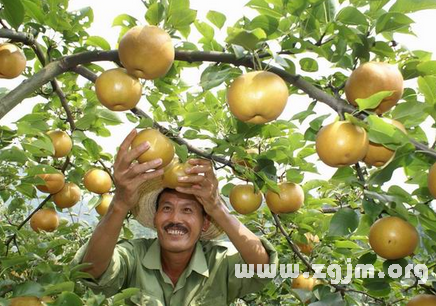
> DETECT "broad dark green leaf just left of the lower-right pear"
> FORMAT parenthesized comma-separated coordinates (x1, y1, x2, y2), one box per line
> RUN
(329, 208, 359, 236)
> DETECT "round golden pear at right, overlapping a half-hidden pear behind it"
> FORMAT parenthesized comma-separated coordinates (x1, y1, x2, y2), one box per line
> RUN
(316, 121, 369, 167)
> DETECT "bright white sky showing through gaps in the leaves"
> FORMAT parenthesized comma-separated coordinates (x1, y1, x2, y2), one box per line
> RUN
(0, 0, 436, 201)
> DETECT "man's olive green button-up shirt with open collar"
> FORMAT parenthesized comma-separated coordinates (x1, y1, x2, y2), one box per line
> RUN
(74, 238, 278, 306)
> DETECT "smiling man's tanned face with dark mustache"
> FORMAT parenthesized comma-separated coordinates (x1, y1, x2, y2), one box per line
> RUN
(154, 190, 209, 253)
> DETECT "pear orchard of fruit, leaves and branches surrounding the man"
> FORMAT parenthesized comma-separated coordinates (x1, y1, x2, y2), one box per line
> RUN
(0, 0, 436, 306)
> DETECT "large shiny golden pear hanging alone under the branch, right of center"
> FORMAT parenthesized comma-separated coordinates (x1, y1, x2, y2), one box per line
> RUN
(227, 71, 289, 124)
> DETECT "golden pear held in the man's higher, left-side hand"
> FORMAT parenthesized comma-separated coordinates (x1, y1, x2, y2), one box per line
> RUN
(132, 129, 174, 169)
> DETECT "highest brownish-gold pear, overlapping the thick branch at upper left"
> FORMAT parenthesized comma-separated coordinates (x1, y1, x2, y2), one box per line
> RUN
(118, 26, 175, 80)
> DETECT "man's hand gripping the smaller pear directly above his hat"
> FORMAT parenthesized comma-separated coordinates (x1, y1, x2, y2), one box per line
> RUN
(176, 159, 221, 216)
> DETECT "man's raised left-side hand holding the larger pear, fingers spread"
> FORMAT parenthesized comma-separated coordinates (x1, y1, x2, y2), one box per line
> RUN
(113, 129, 164, 214)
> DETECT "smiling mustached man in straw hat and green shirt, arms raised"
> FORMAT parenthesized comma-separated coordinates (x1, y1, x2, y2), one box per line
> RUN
(76, 130, 277, 306)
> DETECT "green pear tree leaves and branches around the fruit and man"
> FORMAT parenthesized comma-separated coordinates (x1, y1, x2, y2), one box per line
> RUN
(0, 0, 436, 305)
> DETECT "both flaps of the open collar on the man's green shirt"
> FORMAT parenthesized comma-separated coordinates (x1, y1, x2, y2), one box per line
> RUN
(142, 239, 209, 277)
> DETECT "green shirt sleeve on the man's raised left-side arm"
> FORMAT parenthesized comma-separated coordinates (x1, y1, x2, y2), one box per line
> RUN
(72, 240, 135, 297)
